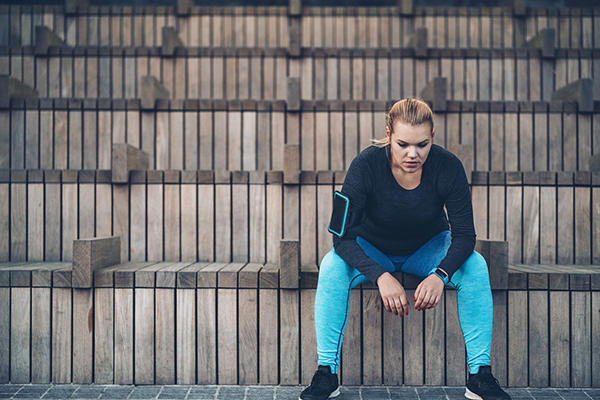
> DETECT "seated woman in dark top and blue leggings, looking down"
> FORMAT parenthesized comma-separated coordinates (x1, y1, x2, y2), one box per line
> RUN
(300, 98, 510, 400)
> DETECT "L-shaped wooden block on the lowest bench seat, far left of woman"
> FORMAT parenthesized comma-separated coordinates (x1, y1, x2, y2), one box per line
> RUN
(72, 237, 121, 288)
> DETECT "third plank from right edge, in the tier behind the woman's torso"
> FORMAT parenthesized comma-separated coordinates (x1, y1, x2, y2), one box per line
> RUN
(556, 187, 575, 264)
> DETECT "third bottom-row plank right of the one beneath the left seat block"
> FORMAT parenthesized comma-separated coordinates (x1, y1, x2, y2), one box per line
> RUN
(134, 288, 155, 385)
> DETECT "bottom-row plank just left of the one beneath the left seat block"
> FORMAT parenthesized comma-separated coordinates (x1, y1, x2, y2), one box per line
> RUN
(52, 288, 72, 383)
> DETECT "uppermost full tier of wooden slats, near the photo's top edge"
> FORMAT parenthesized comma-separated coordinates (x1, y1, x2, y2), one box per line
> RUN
(0, 6, 600, 49)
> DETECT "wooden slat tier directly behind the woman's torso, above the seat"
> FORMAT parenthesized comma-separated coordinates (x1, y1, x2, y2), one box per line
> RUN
(0, 170, 600, 265)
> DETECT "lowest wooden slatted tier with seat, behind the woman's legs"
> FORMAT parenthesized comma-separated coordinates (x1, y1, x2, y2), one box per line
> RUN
(0, 262, 600, 387)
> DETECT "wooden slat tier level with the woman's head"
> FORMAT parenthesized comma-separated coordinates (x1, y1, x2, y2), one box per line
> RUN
(0, 99, 600, 172)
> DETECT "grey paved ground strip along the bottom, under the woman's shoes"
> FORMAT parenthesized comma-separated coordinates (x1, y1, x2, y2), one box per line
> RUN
(0, 384, 600, 400)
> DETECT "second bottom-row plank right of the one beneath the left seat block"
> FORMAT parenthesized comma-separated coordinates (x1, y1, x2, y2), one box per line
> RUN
(114, 288, 133, 385)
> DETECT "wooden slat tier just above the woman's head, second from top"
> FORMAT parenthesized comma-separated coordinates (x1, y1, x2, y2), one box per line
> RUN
(0, 47, 600, 101)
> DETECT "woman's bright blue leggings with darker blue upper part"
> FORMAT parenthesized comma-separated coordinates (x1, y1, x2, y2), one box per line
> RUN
(315, 231, 493, 374)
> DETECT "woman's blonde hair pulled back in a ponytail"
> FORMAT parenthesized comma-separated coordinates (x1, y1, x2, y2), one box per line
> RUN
(373, 97, 433, 147)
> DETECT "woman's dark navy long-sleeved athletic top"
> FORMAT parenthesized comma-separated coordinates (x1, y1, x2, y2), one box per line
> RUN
(333, 144, 475, 283)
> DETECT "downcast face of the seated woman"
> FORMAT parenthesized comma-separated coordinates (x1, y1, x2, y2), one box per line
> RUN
(385, 122, 435, 174)
